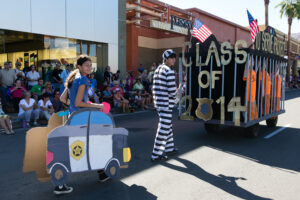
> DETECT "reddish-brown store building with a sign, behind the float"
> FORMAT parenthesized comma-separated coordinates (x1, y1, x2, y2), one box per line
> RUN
(126, 0, 251, 71)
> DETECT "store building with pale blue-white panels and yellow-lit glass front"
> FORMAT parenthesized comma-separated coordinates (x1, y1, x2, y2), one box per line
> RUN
(0, 0, 126, 79)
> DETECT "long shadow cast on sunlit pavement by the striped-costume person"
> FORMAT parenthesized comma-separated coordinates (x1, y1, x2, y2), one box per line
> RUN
(161, 157, 270, 200)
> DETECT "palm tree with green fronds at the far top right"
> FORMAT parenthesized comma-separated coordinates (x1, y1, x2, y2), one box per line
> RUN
(276, 0, 300, 80)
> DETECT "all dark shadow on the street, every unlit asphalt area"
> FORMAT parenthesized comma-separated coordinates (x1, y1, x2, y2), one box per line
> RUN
(0, 94, 300, 200)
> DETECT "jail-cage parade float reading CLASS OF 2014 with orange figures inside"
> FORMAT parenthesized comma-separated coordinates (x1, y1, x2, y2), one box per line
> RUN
(179, 29, 287, 137)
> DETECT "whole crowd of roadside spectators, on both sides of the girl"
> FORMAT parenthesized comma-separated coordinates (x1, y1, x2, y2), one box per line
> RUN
(0, 62, 166, 127)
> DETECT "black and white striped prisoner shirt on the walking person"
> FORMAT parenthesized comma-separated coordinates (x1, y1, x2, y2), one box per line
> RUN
(152, 64, 176, 110)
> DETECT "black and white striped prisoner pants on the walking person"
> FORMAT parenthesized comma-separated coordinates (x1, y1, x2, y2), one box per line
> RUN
(152, 109, 174, 158)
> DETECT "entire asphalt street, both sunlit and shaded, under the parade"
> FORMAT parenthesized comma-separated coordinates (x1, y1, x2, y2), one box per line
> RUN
(0, 90, 300, 200)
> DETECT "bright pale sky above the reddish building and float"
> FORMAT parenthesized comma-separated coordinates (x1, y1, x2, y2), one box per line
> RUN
(160, 0, 300, 33)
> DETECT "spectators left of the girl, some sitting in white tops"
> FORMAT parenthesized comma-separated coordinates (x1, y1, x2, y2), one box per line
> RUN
(0, 62, 66, 128)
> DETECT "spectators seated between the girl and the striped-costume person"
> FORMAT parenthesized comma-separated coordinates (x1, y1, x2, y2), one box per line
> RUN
(97, 63, 157, 112)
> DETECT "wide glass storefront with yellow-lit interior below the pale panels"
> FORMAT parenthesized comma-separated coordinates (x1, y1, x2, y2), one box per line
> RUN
(0, 30, 108, 81)
